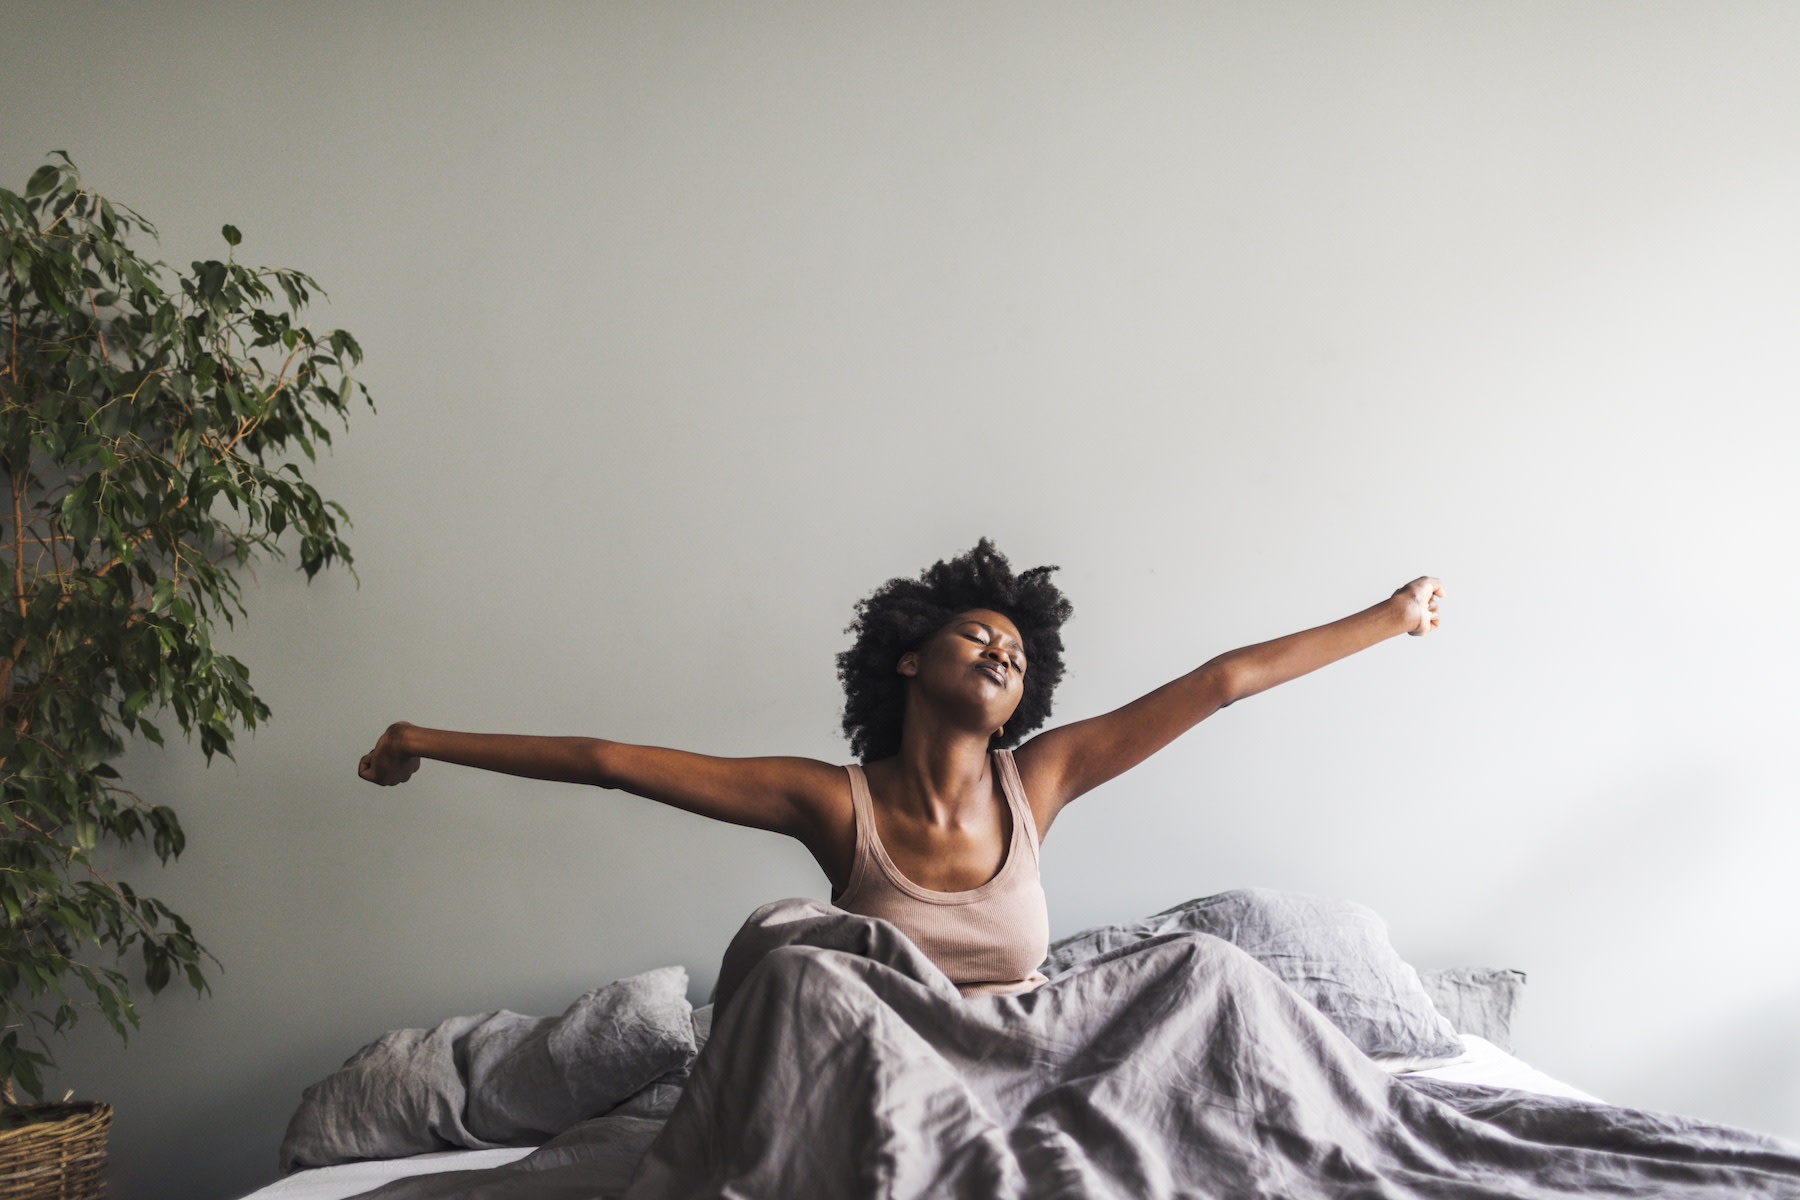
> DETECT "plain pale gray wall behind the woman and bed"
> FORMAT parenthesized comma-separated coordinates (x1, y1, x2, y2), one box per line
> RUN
(0, 0, 1800, 1198)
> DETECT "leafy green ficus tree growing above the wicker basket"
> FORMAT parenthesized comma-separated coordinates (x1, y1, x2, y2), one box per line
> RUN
(0, 153, 373, 1101)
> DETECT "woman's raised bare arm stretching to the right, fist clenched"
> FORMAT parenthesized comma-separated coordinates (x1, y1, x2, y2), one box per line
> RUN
(1017, 576, 1444, 837)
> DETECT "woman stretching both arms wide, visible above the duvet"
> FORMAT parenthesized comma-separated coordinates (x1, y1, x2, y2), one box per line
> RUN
(356, 538, 1444, 995)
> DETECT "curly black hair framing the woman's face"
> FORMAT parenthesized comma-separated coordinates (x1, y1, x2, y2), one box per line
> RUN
(837, 538, 1075, 763)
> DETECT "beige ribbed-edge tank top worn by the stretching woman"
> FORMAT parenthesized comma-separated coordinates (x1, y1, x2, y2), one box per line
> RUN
(833, 750, 1049, 997)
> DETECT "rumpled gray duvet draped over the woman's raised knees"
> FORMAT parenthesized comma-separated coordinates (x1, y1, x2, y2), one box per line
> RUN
(351, 900, 1800, 1200)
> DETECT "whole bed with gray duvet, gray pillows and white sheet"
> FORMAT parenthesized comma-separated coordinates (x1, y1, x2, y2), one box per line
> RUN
(247, 889, 1800, 1200)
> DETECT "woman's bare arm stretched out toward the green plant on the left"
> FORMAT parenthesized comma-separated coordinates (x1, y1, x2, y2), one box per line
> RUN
(356, 721, 848, 842)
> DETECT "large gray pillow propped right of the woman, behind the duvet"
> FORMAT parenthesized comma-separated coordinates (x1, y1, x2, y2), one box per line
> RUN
(1039, 887, 1462, 1060)
